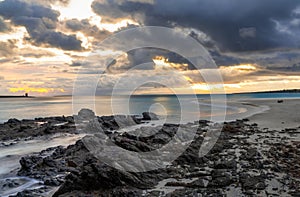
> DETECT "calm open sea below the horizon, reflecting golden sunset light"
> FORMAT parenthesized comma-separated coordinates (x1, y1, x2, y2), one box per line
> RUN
(0, 93, 300, 122)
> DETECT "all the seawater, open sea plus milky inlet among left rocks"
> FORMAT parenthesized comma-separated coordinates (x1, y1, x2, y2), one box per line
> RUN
(0, 93, 300, 197)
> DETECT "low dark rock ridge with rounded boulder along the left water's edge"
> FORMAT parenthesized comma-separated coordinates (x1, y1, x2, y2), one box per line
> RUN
(0, 109, 148, 141)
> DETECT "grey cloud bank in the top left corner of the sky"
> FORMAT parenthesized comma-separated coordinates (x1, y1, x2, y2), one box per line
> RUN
(0, 0, 82, 50)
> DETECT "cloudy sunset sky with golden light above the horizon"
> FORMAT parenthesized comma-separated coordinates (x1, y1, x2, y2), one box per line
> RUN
(0, 0, 300, 96)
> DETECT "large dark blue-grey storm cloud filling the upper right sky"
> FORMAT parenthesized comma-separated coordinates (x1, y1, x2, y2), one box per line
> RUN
(92, 0, 300, 51)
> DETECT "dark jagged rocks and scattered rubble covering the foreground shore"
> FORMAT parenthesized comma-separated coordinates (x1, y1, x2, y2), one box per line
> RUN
(0, 110, 300, 197)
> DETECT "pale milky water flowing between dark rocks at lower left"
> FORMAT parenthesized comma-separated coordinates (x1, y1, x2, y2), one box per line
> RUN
(0, 134, 84, 197)
